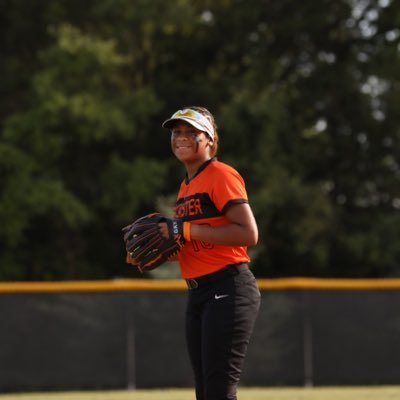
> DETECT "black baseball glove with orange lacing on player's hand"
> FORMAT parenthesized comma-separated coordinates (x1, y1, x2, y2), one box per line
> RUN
(122, 213, 185, 272)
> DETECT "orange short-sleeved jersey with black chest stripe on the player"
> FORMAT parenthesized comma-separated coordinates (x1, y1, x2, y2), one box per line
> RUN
(174, 159, 250, 279)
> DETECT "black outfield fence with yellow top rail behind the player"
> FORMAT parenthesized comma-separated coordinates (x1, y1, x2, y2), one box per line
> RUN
(0, 278, 400, 392)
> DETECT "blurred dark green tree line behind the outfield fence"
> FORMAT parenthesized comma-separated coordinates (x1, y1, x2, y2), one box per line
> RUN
(0, 0, 400, 280)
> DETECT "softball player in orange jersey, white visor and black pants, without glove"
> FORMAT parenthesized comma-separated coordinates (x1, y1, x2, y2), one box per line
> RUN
(162, 107, 260, 400)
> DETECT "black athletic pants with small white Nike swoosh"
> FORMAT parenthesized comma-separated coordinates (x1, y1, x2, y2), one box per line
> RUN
(186, 264, 260, 400)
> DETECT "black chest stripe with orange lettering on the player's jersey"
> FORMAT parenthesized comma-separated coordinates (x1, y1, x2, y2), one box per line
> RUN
(174, 193, 223, 221)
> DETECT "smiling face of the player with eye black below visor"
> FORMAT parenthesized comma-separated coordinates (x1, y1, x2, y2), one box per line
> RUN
(171, 121, 212, 164)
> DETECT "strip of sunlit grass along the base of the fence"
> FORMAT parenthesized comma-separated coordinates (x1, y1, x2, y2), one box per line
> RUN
(0, 386, 400, 400)
